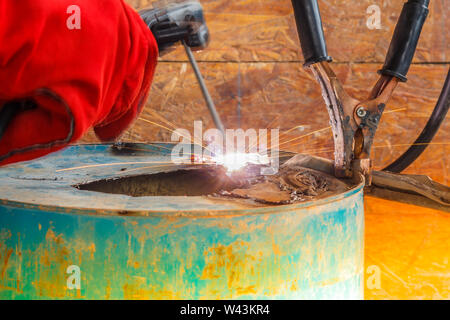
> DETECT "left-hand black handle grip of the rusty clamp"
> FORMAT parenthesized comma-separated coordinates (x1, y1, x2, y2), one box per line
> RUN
(292, 0, 332, 67)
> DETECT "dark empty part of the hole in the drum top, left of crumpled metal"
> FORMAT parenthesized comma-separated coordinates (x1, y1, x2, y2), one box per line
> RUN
(74, 167, 242, 197)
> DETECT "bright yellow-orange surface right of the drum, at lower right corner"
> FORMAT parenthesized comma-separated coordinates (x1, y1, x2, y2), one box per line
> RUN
(365, 196, 450, 300)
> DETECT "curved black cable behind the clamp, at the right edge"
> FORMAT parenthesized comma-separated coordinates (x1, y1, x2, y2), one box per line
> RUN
(383, 69, 450, 173)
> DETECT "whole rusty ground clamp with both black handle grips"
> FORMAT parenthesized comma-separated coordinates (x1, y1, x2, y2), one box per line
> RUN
(292, 0, 429, 185)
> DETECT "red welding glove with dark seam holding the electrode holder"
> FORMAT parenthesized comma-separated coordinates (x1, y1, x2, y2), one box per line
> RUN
(0, 0, 158, 165)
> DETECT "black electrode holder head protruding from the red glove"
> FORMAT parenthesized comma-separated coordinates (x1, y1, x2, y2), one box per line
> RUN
(139, 0, 209, 56)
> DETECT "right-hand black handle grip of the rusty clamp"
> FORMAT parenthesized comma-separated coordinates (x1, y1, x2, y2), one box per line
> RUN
(379, 0, 430, 82)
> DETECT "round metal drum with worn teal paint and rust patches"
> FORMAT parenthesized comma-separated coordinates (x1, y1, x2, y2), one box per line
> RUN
(0, 144, 364, 299)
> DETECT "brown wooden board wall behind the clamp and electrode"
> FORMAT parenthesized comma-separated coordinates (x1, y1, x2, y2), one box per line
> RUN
(83, 0, 450, 185)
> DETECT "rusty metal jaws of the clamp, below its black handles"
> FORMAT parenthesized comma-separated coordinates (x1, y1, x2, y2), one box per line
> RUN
(308, 61, 399, 184)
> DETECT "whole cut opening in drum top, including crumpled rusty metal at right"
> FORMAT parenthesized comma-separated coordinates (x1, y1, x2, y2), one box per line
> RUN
(74, 161, 349, 205)
